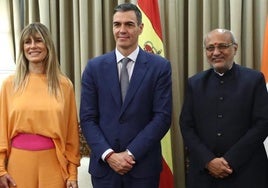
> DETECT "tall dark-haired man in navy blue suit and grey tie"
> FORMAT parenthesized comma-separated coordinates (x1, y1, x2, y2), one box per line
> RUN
(80, 3, 172, 188)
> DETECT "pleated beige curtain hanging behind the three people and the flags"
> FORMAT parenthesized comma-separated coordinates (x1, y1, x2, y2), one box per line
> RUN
(0, 0, 268, 188)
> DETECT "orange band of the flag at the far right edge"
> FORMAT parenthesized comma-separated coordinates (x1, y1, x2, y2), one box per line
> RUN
(261, 17, 268, 89)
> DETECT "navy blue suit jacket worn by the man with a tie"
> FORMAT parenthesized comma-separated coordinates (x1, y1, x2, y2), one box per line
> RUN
(80, 49, 172, 177)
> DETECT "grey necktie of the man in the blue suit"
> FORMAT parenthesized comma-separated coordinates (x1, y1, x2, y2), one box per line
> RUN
(120, 58, 129, 102)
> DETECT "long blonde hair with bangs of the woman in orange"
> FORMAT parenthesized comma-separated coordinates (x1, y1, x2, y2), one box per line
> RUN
(14, 22, 62, 96)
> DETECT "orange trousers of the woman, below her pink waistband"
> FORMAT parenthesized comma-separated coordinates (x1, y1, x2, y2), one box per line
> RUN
(7, 148, 66, 188)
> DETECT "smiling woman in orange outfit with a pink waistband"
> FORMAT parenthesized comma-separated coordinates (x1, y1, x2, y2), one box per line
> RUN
(0, 23, 80, 188)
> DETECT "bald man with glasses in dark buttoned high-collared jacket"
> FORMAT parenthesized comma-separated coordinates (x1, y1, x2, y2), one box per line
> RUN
(180, 29, 268, 188)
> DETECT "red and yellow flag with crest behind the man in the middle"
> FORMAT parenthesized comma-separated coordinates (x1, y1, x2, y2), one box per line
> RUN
(137, 0, 174, 188)
